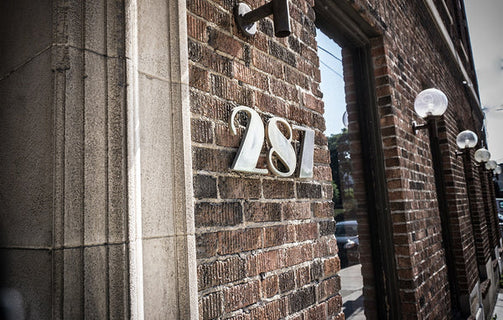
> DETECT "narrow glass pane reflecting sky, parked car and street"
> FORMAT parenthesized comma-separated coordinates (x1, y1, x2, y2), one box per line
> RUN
(316, 29, 365, 320)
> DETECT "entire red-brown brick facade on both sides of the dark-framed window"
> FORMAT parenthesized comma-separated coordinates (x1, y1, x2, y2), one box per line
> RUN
(187, 0, 488, 319)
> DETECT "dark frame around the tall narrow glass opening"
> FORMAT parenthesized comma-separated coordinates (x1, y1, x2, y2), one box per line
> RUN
(314, 0, 401, 319)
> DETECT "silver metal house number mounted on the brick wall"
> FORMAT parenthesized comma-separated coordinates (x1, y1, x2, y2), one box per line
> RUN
(229, 106, 314, 178)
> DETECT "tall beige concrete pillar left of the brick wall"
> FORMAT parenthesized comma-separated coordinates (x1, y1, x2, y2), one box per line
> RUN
(0, 0, 197, 319)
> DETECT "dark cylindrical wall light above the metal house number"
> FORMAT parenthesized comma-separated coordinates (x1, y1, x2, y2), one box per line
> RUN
(234, 0, 292, 38)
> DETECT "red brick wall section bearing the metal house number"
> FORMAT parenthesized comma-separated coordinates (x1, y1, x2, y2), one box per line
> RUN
(187, 0, 341, 319)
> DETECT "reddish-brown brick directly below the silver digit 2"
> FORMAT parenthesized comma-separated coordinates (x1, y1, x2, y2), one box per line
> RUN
(218, 177, 261, 199)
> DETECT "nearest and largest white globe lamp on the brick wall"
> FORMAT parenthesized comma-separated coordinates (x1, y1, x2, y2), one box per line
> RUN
(412, 88, 448, 136)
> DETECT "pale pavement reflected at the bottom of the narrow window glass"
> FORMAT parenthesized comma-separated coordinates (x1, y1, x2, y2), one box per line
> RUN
(339, 264, 366, 320)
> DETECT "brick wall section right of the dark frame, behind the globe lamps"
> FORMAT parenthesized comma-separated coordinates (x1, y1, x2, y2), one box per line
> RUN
(342, 1, 488, 318)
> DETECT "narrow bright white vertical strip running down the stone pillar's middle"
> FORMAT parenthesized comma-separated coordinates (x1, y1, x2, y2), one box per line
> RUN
(126, 0, 144, 320)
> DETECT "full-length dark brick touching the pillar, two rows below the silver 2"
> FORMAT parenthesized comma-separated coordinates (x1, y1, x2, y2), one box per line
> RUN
(194, 202, 243, 227)
